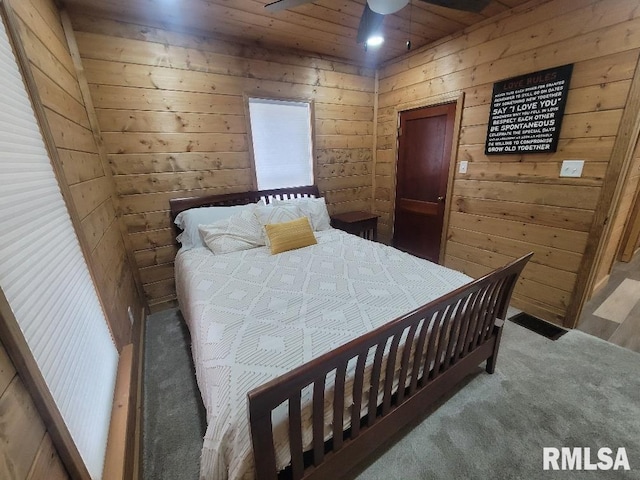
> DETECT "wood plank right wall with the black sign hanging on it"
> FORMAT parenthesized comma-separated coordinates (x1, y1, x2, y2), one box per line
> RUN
(374, 0, 640, 324)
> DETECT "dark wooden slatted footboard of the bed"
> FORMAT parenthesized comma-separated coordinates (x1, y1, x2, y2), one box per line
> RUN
(248, 254, 532, 480)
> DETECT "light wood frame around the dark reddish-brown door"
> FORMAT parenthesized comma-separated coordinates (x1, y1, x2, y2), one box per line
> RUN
(384, 90, 464, 265)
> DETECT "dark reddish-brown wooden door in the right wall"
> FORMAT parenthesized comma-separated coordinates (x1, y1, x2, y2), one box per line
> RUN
(393, 103, 456, 263)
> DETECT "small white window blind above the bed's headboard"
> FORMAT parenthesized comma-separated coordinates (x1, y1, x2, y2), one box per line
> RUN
(249, 98, 313, 190)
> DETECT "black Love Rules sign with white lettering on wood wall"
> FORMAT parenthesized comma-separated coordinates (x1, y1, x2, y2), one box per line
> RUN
(484, 64, 573, 155)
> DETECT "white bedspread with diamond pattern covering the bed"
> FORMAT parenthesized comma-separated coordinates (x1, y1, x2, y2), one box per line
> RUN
(175, 229, 471, 480)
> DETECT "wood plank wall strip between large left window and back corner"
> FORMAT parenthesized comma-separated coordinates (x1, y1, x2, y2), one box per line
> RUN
(10, 0, 144, 350)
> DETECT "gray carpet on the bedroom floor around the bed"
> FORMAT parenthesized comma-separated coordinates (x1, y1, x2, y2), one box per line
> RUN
(143, 311, 640, 480)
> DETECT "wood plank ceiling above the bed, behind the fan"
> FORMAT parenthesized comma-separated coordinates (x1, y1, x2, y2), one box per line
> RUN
(64, 0, 529, 67)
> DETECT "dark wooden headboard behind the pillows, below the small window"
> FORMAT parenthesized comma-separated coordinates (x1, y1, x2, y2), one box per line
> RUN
(169, 185, 320, 233)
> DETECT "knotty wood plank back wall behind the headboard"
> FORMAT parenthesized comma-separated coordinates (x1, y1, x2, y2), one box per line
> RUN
(70, 15, 374, 311)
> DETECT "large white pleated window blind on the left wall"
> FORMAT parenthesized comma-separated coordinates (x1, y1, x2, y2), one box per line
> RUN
(0, 13, 118, 479)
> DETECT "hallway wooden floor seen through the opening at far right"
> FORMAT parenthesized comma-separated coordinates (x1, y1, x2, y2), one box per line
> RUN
(578, 253, 640, 352)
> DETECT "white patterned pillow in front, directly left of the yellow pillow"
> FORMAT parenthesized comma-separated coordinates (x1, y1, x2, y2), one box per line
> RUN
(198, 208, 264, 255)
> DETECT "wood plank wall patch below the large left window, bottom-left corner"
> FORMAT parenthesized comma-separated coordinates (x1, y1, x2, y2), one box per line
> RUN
(0, 343, 69, 480)
